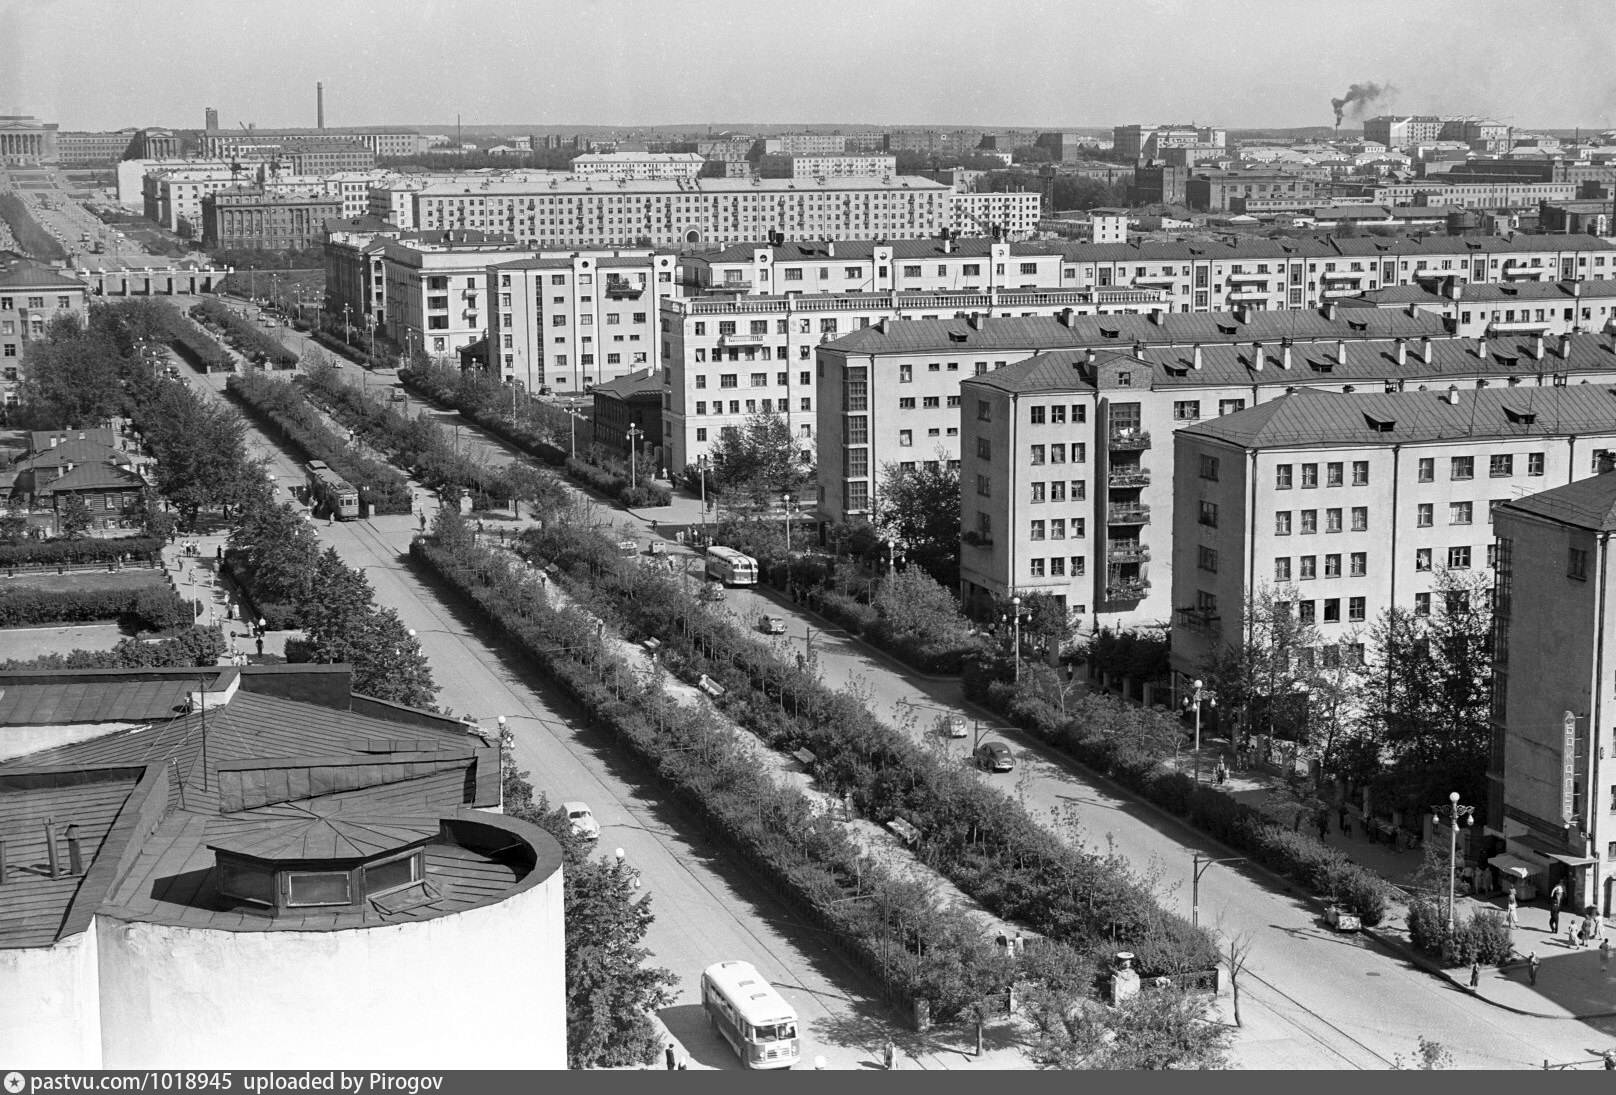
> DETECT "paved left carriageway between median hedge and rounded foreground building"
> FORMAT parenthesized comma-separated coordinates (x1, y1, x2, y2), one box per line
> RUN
(192, 375, 973, 1069)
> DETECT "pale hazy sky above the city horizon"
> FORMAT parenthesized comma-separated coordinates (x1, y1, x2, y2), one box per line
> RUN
(0, 0, 1616, 129)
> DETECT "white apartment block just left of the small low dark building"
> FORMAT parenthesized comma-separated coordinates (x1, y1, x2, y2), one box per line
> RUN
(486, 250, 679, 392)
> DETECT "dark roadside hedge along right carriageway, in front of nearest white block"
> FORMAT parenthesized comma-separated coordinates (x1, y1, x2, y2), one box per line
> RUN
(965, 665, 1387, 927)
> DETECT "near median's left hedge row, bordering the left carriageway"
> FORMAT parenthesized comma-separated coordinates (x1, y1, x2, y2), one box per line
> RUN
(410, 535, 1027, 1019)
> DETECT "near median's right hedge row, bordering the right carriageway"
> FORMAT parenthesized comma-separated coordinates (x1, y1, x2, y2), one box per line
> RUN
(522, 527, 1217, 974)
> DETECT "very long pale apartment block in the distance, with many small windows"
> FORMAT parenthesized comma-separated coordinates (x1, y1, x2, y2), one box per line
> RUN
(412, 176, 953, 249)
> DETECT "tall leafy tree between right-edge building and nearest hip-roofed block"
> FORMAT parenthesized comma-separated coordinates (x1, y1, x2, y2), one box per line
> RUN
(1353, 570, 1493, 804)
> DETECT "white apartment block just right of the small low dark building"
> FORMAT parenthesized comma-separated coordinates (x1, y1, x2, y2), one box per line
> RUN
(661, 282, 1164, 468)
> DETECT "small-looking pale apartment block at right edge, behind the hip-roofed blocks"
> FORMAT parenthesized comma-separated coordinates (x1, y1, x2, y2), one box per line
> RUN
(1341, 278, 1616, 338)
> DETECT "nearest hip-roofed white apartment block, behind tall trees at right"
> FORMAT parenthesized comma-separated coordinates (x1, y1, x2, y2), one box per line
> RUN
(1172, 385, 1616, 707)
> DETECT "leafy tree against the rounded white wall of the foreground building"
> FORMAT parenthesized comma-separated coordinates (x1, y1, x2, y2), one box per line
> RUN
(504, 753, 677, 1069)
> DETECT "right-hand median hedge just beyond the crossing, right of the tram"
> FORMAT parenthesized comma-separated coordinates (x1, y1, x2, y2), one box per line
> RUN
(304, 370, 511, 509)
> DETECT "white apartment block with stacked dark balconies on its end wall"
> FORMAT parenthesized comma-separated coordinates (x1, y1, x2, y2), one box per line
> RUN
(950, 326, 1616, 628)
